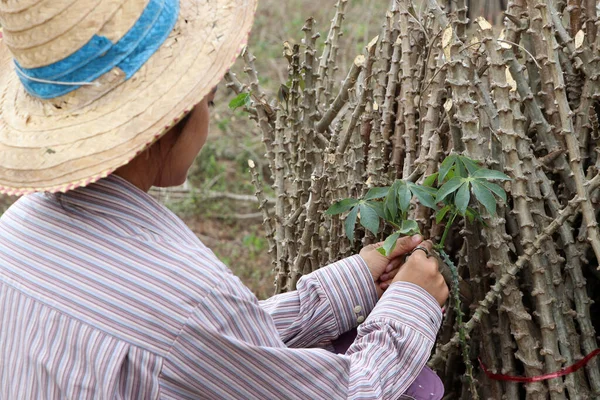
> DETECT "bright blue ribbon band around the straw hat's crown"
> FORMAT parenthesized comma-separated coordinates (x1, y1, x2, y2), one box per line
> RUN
(15, 0, 179, 99)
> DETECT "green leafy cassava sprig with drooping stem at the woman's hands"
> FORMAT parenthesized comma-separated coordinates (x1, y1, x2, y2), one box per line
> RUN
(325, 155, 510, 392)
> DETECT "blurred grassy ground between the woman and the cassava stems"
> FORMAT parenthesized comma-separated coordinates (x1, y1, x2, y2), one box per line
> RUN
(152, 0, 388, 298)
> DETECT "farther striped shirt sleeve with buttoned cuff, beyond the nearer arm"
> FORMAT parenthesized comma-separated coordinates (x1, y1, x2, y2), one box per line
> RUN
(259, 255, 377, 348)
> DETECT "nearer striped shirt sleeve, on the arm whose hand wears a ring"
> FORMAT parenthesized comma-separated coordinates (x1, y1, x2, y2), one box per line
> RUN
(161, 279, 441, 400)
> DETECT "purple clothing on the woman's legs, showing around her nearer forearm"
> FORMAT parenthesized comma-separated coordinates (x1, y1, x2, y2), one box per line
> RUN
(333, 329, 444, 400)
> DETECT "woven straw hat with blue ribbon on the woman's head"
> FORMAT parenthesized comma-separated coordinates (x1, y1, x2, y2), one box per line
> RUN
(0, 0, 257, 195)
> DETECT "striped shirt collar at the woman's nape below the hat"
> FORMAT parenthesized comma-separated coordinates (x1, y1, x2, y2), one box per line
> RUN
(63, 174, 200, 245)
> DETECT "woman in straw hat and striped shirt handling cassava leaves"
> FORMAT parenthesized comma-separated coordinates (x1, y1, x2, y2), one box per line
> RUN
(0, 0, 448, 400)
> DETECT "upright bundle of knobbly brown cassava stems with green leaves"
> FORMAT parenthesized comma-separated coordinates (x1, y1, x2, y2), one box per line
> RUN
(227, 0, 600, 400)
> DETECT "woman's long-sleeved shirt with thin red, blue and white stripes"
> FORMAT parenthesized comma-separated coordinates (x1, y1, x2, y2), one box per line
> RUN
(0, 176, 441, 400)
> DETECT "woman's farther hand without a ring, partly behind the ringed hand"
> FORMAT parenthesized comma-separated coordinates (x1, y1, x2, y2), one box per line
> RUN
(359, 235, 423, 297)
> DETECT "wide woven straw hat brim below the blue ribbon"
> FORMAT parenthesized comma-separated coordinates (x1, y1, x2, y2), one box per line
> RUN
(0, 0, 256, 195)
